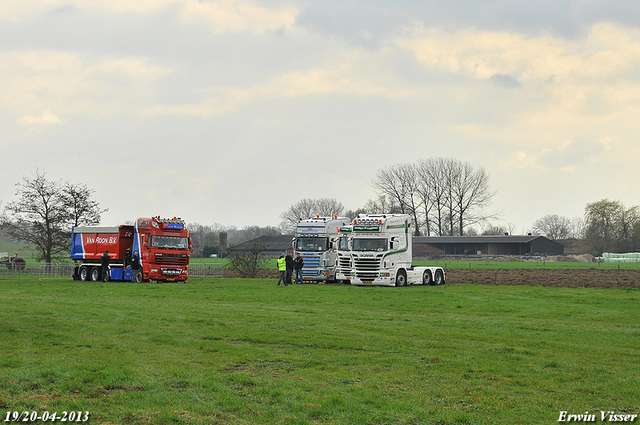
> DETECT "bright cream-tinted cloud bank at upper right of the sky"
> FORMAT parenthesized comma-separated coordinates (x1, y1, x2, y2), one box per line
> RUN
(397, 24, 640, 81)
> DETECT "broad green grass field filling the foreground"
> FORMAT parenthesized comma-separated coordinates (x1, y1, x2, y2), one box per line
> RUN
(0, 279, 640, 425)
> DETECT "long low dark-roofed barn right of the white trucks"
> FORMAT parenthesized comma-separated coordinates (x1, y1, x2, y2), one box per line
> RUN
(413, 235, 564, 257)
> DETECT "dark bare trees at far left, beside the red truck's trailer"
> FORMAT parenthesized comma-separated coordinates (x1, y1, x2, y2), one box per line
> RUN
(2, 170, 101, 263)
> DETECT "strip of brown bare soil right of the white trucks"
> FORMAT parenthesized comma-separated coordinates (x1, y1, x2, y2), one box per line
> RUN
(447, 268, 640, 288)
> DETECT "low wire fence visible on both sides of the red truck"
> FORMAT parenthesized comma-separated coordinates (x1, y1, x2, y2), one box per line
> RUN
(0, 263, 224, 280)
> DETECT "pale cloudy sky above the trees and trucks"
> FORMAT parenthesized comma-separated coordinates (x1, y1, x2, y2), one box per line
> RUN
(0, 0, 640, 233)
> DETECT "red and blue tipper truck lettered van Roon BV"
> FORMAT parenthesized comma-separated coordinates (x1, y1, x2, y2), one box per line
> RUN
(71, 216, 191, 282)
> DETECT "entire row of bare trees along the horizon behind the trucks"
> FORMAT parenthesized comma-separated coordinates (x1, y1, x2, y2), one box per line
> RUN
(0, 167, 640, 262)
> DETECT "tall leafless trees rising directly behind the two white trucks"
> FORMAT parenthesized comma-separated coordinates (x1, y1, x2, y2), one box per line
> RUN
(281, 158, 497, 236)
